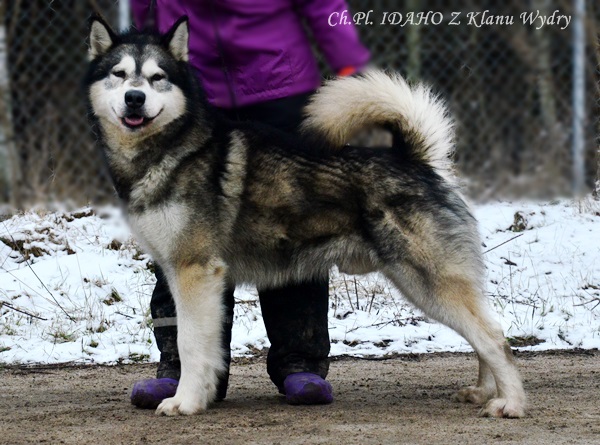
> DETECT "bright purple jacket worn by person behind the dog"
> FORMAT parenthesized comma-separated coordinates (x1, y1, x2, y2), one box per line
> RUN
(131, 0, 369, 108)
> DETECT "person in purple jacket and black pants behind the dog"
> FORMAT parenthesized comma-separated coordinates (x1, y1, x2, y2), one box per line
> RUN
(131, 0, 369, 408)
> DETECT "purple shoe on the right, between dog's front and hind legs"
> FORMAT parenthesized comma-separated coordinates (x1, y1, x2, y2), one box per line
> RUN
(283, 372, 333, 405)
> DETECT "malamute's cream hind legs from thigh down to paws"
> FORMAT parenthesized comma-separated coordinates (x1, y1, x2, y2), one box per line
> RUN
(386, 263, 525, 417)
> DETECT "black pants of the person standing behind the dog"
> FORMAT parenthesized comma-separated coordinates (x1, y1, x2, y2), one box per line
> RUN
(150, 94, 330, 399)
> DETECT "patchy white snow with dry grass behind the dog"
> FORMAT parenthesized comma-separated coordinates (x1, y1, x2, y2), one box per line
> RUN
(0, 199, 600, 364)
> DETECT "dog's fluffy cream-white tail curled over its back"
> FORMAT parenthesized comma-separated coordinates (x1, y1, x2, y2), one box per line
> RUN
(303, 70, 454, 178)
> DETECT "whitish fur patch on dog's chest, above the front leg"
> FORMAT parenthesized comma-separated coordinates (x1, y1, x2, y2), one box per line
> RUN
(129, 203, 189, 261)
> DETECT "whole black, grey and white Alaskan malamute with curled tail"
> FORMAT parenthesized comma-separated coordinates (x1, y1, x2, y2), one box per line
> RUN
(87, 18, 525, 417)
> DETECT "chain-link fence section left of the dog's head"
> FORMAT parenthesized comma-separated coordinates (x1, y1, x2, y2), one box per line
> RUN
(0, 0, 120, 207)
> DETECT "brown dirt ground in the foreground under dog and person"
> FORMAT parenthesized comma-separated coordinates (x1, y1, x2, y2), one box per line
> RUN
(0, 351, 600, 445)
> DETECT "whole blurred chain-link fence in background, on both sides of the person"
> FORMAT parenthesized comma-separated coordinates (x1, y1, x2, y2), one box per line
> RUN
(0, 0, 600, 205)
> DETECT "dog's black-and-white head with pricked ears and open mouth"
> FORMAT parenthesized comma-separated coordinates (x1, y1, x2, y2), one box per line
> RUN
(87, 17, 189, 140)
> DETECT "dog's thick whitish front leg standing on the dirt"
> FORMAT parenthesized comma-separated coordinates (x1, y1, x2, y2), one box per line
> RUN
(156, 261, 225, 416)
